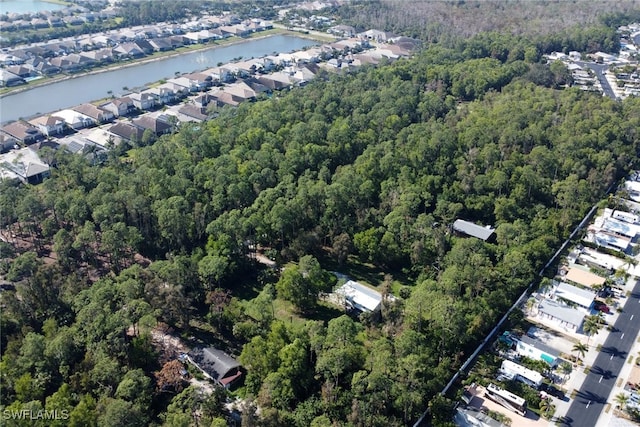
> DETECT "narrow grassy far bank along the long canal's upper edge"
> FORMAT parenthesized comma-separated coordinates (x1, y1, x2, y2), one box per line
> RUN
(0, 28, 319, 99)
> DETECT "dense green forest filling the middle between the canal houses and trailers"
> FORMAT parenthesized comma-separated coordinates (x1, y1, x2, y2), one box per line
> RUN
(0, 2, 640, 427)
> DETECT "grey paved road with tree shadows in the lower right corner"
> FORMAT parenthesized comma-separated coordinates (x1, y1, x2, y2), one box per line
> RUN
(559, 281, 640, 427)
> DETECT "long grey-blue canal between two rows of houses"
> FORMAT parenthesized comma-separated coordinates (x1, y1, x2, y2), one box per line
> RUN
(0, 35, 317, 123)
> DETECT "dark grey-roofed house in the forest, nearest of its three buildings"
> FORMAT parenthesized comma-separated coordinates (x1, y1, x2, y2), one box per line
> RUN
(185, 347, 242, 389)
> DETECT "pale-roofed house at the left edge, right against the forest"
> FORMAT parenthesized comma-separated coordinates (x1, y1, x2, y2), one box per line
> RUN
(0, 147, 50, 184)
